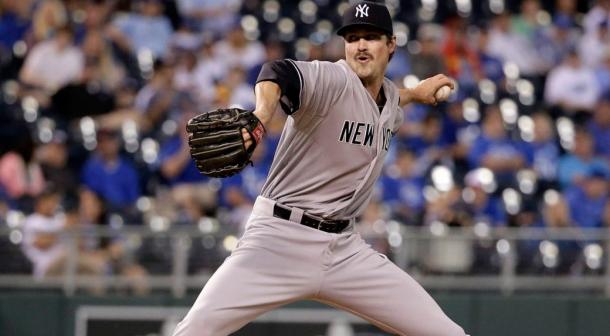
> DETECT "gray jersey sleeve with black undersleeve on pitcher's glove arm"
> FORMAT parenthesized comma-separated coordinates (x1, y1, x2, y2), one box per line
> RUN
(256, 59, 347, 115)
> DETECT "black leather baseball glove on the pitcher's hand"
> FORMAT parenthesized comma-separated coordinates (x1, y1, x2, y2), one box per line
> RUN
(186, 108, 265, 177)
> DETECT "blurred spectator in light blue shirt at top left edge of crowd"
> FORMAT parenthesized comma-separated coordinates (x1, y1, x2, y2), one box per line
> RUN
(106, 0, 173, 59)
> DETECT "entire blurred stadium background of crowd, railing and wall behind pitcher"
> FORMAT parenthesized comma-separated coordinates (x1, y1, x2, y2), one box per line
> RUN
(0, 0, 610, 336)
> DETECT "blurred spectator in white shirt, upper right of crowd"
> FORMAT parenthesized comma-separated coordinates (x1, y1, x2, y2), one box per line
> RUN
(544, 50, 599, 115)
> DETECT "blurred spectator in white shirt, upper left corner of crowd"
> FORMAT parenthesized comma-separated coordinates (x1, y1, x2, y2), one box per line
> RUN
(19, 26, 84, 93)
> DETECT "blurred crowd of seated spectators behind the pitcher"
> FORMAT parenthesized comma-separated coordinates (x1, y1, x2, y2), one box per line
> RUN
(0, 0, 610, 284)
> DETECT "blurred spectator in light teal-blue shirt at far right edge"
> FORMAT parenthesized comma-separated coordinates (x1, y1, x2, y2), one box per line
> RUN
(558, 128, 608, 188)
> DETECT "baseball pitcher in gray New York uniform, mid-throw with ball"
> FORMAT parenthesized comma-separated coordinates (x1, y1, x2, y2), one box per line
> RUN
(174, 2, 465, 336)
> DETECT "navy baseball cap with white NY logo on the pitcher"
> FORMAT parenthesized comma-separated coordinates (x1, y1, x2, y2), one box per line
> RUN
(337, 1, 394, 36)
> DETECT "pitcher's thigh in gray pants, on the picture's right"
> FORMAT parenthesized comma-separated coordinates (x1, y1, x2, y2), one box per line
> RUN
(321, 250, 465, 336)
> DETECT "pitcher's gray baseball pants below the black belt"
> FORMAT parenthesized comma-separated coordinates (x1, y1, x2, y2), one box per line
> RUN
(174, 197, 465, 336)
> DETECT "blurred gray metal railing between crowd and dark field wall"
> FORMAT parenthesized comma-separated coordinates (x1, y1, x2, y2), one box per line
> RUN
(0, 222, 610, 297)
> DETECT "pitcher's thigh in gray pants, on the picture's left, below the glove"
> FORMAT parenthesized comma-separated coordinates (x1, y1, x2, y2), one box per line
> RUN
(174, 244, 312, 336)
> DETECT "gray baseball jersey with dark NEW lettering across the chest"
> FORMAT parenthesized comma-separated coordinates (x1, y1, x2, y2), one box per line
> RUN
(262, 60, 403, 219)
